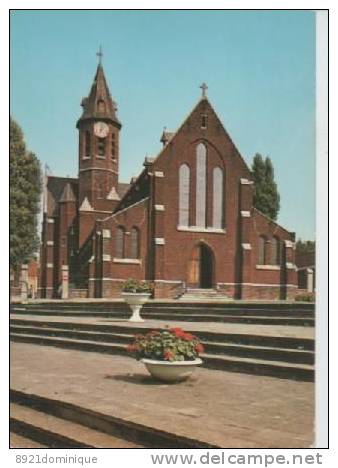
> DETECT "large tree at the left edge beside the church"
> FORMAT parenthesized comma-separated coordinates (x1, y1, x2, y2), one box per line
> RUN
(10, 118, 41, 271)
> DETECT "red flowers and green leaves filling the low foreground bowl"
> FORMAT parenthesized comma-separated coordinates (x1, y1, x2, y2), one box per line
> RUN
(127, 328, 204, 362)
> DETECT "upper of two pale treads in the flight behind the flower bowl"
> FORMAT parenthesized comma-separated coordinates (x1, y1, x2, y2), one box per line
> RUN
(11, 325, 314, 354)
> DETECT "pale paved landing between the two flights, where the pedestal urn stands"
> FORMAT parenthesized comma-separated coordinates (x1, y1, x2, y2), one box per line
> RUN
(11, 312, 315, 339)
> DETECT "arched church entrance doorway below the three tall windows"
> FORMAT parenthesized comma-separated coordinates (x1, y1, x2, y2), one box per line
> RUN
(188, 243, 214, 289)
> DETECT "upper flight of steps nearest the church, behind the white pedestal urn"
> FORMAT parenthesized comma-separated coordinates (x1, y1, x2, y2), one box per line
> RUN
(11, 301, 315, 327)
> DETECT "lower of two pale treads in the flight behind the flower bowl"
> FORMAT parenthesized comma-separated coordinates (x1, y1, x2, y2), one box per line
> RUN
(11, 334, 313, 370)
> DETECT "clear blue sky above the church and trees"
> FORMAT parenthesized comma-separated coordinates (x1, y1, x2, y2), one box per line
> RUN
(11, 10, 315, 239)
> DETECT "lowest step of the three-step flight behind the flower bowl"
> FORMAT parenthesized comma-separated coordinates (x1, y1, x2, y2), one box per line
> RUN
(10, 332, 314, 381)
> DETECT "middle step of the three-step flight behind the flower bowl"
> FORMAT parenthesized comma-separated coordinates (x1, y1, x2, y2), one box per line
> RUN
(10, 325, 314, 365)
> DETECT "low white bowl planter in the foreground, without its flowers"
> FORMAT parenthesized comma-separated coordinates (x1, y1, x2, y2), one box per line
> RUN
(141, 358, 203, 382)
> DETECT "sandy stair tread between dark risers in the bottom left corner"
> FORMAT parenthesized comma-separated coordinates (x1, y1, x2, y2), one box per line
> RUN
(10, 403, 142, 448)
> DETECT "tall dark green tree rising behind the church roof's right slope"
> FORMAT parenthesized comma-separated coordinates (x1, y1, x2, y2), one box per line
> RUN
(252, 153, 280, 221)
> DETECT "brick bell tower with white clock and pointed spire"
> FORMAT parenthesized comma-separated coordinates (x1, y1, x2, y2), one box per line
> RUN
(76, 48, 121, 212)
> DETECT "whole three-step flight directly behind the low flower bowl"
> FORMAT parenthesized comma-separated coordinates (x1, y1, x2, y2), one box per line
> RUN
(10, 317, 314, 381)
